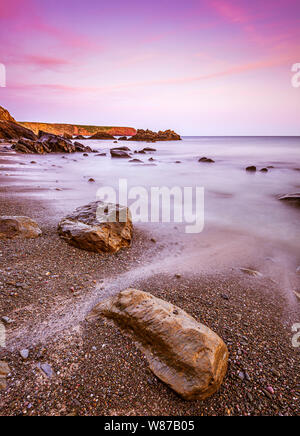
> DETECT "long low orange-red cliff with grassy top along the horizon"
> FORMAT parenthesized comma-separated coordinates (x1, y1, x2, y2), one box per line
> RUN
(19, 122, 136, 136)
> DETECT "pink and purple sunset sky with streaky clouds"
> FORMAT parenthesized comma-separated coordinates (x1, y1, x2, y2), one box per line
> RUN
(0, 0, 300, 136)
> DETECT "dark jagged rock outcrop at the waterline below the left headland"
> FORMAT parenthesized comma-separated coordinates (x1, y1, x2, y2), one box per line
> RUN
(13, 131, 92, 154)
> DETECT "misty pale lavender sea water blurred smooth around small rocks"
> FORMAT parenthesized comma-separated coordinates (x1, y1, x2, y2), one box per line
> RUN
(2, 137, 300, 251)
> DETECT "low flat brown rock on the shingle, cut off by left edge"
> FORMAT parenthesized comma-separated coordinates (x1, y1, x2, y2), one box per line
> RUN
(0, 216, 42, 239)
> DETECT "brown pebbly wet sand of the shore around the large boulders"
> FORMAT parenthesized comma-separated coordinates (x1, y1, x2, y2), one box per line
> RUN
(0, 146, 300, 416)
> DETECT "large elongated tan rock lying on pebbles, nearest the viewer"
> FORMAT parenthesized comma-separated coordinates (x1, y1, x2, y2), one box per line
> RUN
(87, 289, 228, 400)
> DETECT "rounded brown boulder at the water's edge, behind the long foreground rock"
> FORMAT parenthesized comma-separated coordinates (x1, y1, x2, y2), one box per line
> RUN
(58, 201, 133, 253)
